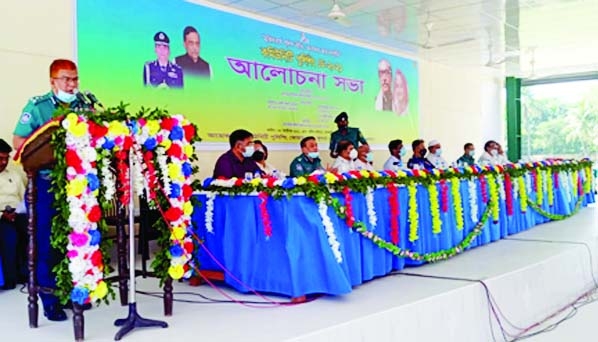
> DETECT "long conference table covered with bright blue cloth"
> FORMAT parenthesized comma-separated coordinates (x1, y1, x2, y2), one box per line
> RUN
(193, 162, 594, 297)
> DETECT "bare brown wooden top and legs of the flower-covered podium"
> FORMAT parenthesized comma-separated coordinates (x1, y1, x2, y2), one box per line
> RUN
(19, 121, 173, 341)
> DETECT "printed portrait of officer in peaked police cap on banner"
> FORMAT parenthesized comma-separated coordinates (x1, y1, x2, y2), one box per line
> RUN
(143, 31, 183, 88)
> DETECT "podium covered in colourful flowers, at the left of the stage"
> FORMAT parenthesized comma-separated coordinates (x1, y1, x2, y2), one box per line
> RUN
(15, 105, 198, 340)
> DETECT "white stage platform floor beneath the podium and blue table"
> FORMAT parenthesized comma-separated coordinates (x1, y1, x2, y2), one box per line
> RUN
(0, 205, 598, 342)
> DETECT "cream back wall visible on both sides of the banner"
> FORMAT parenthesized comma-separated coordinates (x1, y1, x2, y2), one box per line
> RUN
(0, 0, 503, 177)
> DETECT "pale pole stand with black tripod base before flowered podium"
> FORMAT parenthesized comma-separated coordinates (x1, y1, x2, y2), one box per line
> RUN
(114, 149, 168, 341)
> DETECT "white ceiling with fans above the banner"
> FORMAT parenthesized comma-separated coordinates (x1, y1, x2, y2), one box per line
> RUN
(203, 0, 598, 78)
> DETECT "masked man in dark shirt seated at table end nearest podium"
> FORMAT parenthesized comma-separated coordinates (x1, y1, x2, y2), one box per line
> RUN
(214, 129, 263, 179)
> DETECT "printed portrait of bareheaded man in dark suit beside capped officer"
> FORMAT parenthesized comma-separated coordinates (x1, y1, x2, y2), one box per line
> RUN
(174, 26, 212, 78)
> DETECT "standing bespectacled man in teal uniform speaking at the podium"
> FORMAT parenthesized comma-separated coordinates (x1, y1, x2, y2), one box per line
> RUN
(13, 59, 88, 321)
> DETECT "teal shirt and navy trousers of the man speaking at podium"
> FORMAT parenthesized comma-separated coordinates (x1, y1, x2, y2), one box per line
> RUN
(13, 92, 85, 320)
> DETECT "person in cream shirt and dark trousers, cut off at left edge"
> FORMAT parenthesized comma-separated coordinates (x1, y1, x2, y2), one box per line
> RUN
(0, 139, 27, 290)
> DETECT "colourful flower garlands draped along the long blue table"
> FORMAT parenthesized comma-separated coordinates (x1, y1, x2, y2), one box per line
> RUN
(203, 160, 591, 263)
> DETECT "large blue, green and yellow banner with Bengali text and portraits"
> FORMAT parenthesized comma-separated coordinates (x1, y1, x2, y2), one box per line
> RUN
(77, 0, 419, 148)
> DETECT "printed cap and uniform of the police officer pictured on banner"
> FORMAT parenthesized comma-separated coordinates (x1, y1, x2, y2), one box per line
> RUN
(143, 32, 183, 88)
